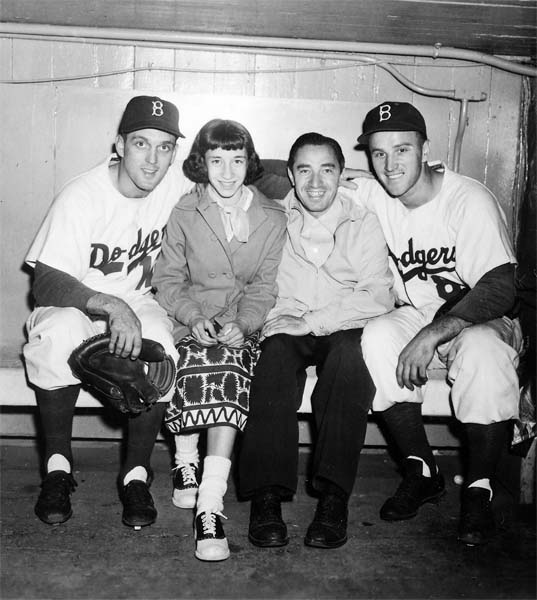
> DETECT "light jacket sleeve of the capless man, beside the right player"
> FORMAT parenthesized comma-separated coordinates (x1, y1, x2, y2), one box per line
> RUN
(304, 211, 394, 335)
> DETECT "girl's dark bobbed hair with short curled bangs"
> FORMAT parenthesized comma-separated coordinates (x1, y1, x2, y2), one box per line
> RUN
(183, 119, 263, 185)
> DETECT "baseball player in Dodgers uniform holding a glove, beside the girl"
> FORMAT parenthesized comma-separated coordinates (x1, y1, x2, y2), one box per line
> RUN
(24, 96, 192, 528)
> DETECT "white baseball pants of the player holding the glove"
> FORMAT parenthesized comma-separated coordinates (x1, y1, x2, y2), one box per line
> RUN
(23, 295, 178, 402)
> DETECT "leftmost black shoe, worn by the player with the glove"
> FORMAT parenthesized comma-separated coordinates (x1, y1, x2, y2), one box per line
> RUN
(34, 471, 77, 525)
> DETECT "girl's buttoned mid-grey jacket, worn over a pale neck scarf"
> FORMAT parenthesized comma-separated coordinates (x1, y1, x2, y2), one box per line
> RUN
(152, 185, 287, 341)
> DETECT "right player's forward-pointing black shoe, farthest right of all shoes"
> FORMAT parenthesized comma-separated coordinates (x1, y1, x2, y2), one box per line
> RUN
(458, 487, 496, 546)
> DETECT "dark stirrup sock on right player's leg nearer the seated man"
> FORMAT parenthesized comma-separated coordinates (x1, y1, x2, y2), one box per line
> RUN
(381, 402, 436, 475)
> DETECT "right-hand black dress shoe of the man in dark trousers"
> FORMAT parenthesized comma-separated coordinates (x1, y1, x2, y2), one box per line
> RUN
(304, 493, 348, 548)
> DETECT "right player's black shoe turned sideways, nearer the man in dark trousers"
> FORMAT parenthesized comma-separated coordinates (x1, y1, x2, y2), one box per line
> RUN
(380, 458, 446, 521)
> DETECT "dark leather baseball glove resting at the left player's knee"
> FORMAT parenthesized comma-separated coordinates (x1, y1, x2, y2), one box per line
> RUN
(68, 334, 175, 413)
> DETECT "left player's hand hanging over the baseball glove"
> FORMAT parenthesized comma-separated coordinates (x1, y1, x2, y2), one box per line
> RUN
(86, 293, 142, 360)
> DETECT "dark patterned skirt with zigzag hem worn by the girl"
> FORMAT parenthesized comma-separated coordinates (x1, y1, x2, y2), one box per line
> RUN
(165, 334, 260, 433)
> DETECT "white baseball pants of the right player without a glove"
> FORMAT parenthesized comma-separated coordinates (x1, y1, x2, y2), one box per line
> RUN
(362, 306, 522, 425)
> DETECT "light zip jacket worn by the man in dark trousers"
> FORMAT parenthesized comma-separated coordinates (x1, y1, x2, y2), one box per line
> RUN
(268, 190, 394, 335)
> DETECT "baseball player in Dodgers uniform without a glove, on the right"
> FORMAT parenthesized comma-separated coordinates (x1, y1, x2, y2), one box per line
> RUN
(352, 102, 522, 545)
